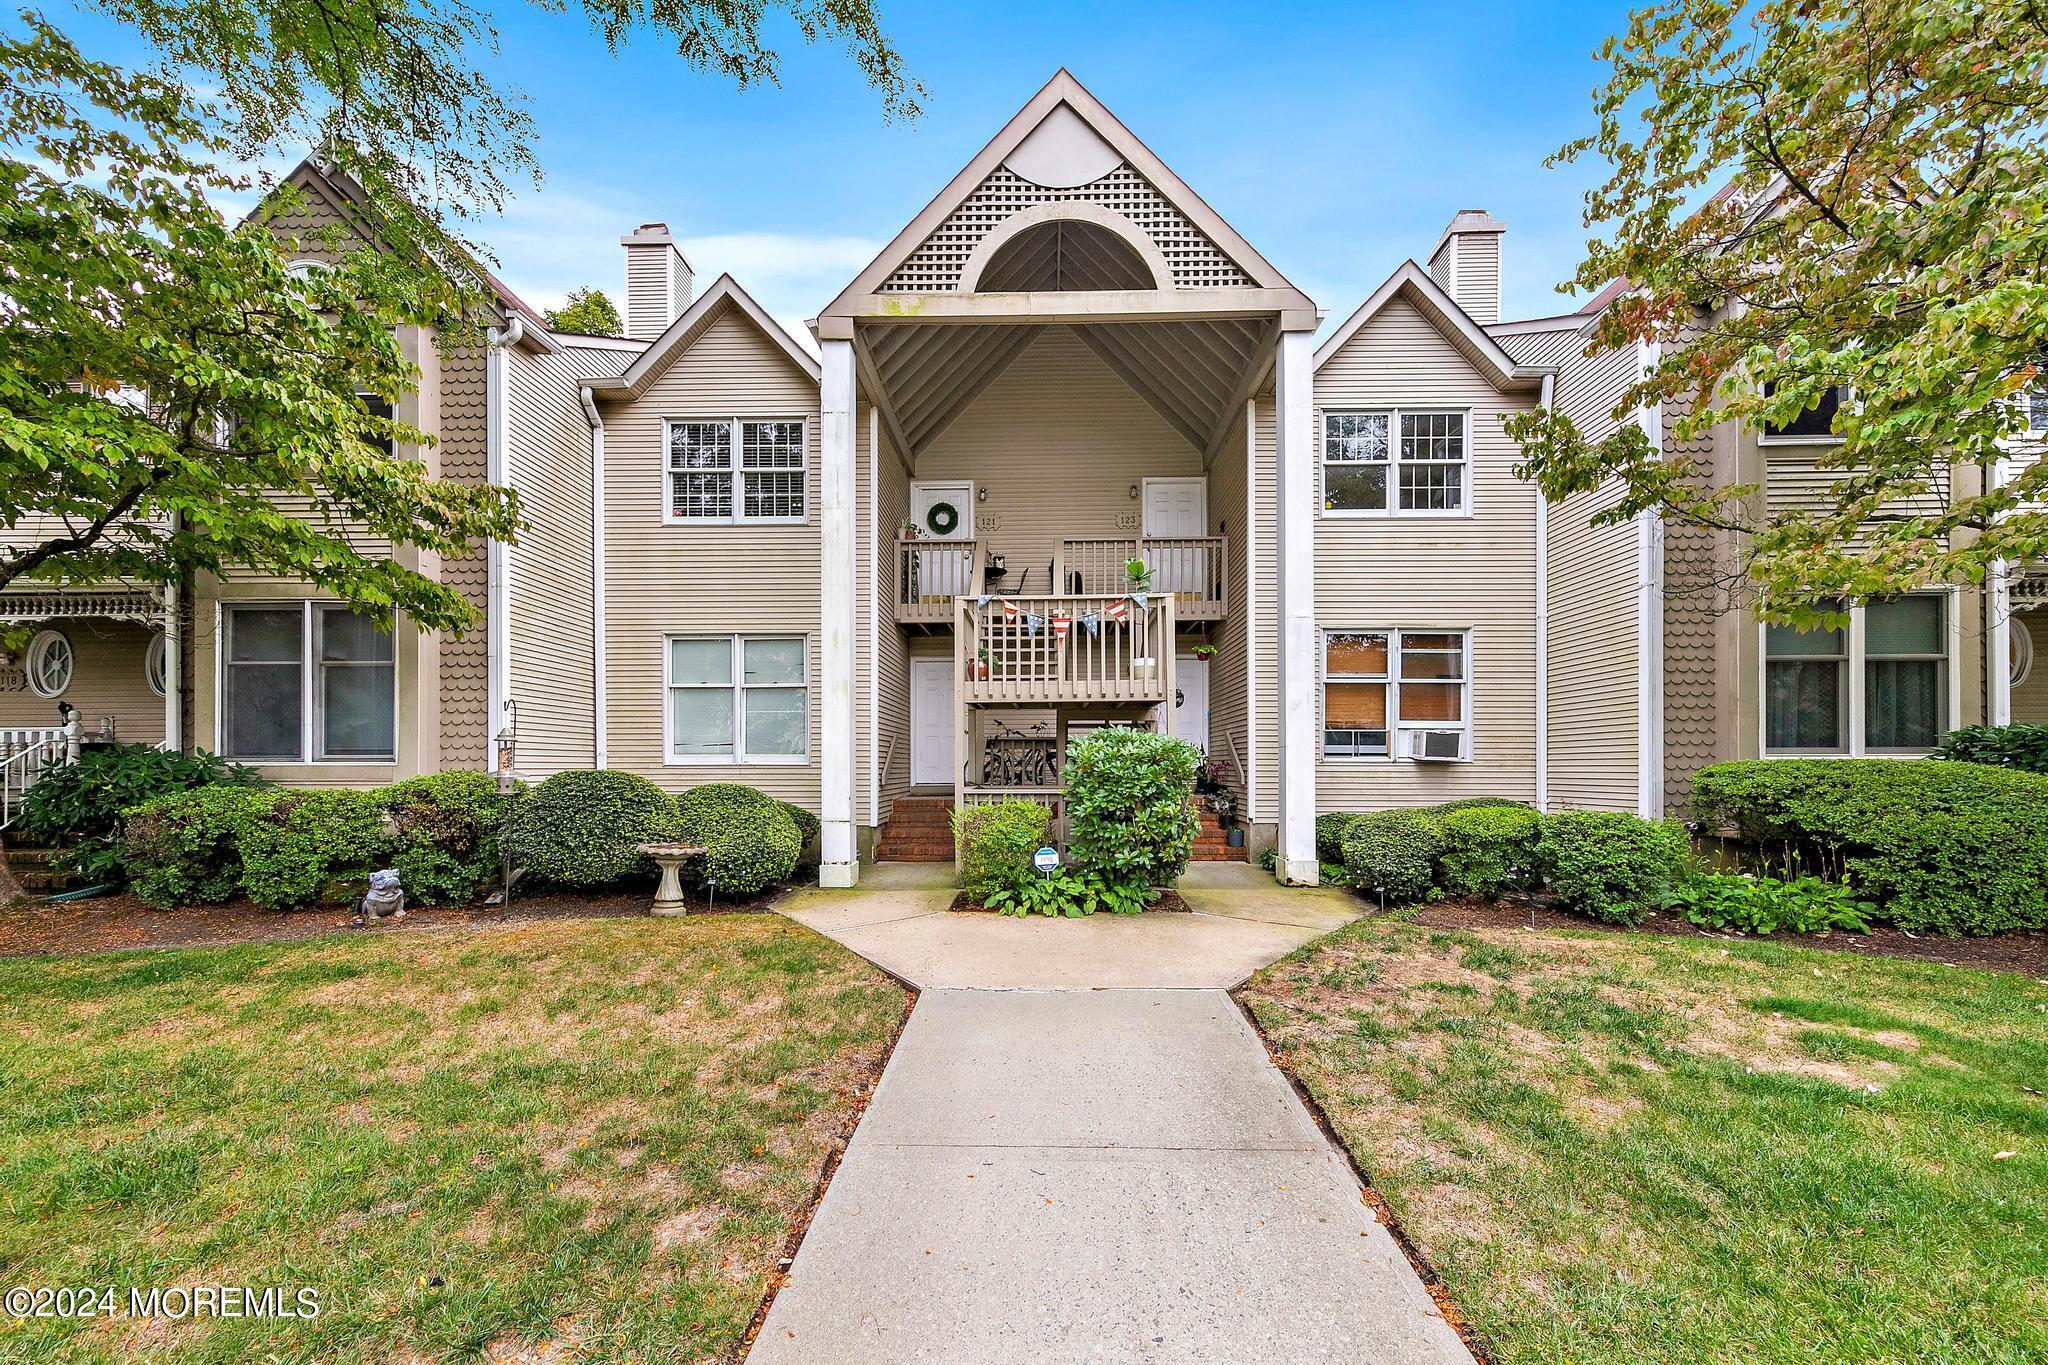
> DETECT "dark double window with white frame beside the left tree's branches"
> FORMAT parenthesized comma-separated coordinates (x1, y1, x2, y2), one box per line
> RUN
(221, 602, 397, 763)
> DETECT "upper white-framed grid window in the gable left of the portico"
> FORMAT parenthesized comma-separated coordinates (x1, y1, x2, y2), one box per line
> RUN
(662, 417, 809, 522)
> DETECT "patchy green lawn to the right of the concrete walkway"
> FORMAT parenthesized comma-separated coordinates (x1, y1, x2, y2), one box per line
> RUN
(1245, 921, 2048, 1365)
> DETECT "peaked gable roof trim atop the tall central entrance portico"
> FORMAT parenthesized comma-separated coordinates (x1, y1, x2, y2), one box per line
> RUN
(821, 68, 1313, 317)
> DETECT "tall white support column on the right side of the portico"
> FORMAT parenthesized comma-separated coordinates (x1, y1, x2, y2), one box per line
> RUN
(1274, 332, 1319, 886)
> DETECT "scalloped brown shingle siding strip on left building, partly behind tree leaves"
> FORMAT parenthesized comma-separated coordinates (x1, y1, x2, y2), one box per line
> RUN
(438, 346, 489, 769)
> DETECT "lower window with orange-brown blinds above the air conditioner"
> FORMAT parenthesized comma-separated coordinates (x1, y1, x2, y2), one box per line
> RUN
(1323, 630, 1473, 757)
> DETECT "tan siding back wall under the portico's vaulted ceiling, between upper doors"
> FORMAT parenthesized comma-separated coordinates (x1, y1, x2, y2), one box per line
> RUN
(918, 327, 1202, 591)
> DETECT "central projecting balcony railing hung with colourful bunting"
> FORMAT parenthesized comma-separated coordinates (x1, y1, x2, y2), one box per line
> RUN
(952, 593, 1176, 706)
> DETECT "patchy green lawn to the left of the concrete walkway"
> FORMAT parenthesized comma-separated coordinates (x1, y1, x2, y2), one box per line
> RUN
(0, 915, 903, 1363)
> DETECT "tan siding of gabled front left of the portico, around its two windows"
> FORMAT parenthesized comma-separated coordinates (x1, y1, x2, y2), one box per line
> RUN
(602, 307, 819, 810)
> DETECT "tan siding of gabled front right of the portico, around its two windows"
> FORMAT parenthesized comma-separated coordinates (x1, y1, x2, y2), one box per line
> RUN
(1315, 299, 1536, 810)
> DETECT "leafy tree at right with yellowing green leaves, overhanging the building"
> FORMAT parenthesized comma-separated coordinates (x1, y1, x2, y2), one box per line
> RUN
(1507, 0, 2048, 624)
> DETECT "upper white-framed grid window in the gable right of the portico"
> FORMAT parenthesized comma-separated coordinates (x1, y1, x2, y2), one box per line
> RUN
(1321, 407, 1473, 516)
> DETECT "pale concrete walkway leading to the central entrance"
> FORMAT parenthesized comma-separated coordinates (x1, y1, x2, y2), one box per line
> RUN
(748, 864, 1470, 1365)
